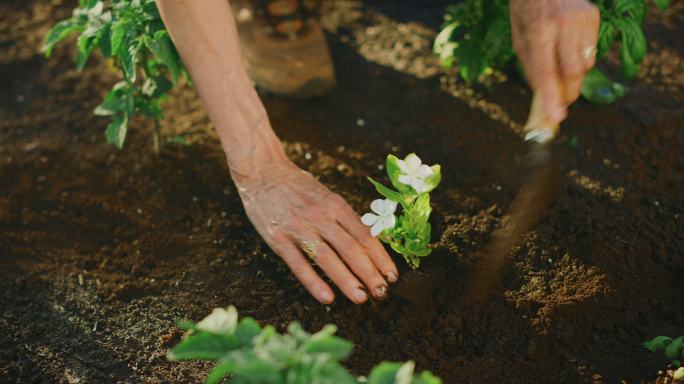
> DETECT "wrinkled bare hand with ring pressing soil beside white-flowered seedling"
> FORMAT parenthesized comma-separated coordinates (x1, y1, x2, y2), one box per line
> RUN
(233, 160, 398, 304)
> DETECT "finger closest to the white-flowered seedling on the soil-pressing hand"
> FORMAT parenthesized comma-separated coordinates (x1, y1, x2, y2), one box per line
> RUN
(337, 204, 399, 283)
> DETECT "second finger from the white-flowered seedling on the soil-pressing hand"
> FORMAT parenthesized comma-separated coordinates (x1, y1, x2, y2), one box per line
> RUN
(320, 223, 387, 299)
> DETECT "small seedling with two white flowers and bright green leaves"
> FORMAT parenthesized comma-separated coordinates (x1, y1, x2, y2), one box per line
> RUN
(361, 153, 442, 268)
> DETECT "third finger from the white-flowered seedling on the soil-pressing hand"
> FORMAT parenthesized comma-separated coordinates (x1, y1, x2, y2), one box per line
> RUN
(314, 241, 368, 304)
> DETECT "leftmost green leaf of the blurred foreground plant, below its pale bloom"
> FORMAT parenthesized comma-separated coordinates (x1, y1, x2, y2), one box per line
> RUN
(166, 332, 240, 361)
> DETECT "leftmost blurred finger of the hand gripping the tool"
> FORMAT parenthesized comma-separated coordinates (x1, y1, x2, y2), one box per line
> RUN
(526, 22, 566, 123)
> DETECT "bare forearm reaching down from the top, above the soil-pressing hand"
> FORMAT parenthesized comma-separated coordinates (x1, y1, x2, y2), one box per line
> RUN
(157, 0, 285, 177)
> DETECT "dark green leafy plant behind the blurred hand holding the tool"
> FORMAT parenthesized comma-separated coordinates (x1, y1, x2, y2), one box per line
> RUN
(433, 0, 670, 103)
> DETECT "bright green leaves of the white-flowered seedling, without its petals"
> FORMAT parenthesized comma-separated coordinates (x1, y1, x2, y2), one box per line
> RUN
(368, 153, 442, 268)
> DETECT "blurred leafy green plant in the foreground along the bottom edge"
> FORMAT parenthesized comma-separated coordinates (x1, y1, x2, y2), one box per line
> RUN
(167, 306, 442, 384)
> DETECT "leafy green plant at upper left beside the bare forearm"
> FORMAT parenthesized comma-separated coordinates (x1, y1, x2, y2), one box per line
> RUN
(43, 0, 189, 151)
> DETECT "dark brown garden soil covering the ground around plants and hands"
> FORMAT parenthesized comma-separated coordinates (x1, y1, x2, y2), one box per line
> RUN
(0, 0, 684, 383)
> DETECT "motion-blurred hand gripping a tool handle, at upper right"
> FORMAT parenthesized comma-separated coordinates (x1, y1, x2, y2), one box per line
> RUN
(509, 0, 600, 124)
